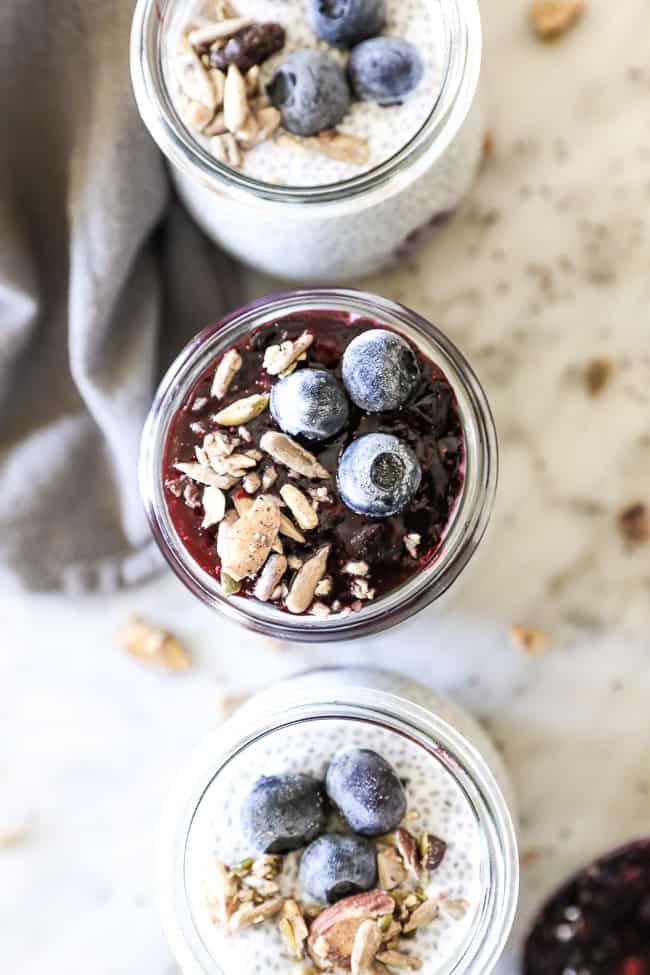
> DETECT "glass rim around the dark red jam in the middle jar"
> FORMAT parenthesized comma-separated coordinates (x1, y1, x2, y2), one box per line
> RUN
(140, 288, 498, 642)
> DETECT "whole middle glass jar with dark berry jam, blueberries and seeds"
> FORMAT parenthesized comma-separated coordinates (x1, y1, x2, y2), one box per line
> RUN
(141, 289, 497, 640)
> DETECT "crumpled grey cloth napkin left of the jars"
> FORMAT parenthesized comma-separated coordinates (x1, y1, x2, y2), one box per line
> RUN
(0, 0, 234, 591)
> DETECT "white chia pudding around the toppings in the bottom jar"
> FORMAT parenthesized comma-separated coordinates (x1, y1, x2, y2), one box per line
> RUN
(186, 718, 482, 975)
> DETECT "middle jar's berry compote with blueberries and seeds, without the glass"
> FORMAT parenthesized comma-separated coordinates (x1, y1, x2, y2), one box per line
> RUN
(163, 311, 465, 617)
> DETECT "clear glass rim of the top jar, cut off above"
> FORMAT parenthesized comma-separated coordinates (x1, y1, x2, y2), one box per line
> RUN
(130, 0, 482, 212)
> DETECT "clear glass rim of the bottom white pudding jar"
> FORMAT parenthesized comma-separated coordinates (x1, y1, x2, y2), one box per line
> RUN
(156, 681, 519, 975)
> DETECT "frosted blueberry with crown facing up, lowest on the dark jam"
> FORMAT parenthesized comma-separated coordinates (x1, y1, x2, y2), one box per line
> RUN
(337, 433, 422, 518)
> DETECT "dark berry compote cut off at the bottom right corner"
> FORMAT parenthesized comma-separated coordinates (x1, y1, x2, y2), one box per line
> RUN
(524, 839, 650, 975)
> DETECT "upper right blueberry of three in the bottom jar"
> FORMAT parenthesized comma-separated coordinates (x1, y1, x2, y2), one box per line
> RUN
(325, 748, 406, 836)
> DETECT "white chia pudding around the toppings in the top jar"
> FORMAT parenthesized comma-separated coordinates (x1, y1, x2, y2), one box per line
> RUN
(168, 0, 445, 187)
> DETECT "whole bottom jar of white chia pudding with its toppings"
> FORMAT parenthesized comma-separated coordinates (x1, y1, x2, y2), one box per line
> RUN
(158, 668, 517, 975)
